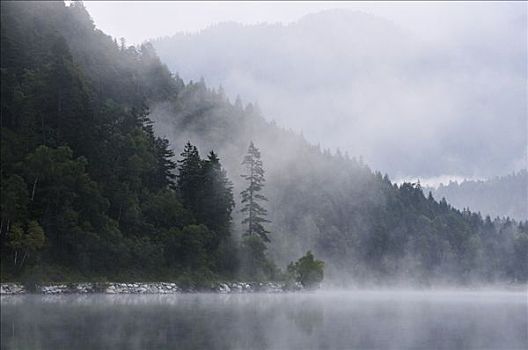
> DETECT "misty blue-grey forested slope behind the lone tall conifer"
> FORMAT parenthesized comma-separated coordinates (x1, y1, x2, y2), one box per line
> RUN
(151, 81, 528, 283)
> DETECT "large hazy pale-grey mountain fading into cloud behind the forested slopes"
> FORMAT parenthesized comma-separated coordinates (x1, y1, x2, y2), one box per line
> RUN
(152, 10, 528, 178)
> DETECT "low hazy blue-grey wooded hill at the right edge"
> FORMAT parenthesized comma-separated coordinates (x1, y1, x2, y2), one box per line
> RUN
(426, 170, 528, 220)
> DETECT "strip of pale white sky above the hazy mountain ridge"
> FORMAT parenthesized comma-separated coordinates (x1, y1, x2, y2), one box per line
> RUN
(84, 1, 526, 44)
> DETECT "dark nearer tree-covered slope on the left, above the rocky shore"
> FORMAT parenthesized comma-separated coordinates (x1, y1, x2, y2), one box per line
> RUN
(0, 2, 236, 279)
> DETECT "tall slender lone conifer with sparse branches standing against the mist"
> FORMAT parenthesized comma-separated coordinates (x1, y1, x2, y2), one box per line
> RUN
(240, 142, 270, 242)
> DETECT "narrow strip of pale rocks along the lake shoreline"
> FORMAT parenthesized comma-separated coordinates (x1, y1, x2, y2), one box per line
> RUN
(0, 282, 304, 296)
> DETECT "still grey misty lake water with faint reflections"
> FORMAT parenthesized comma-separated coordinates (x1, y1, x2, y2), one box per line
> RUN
(1, 291, 528, 350)
